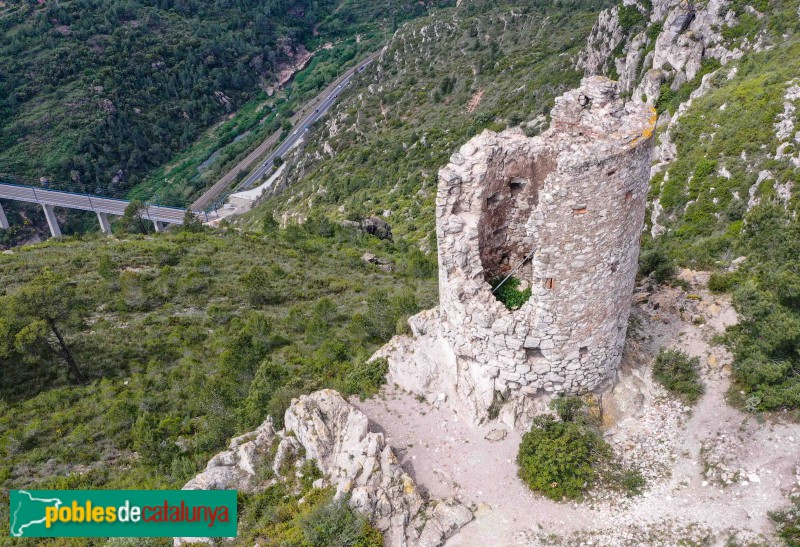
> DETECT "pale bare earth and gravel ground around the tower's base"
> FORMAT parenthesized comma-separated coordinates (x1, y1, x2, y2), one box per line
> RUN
(354, 271, 800, 546)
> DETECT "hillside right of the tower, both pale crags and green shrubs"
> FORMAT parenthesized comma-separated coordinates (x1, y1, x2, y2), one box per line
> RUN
(579, 1, 800, 416)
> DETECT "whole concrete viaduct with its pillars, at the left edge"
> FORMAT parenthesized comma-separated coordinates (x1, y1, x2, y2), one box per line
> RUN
(0, 183, 194, 237)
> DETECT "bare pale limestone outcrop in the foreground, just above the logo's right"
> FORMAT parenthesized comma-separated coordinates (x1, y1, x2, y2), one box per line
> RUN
(175, 389, 472, 547)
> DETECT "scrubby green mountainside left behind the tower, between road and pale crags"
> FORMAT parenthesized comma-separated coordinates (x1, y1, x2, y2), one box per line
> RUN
(247, 0, 604, 246)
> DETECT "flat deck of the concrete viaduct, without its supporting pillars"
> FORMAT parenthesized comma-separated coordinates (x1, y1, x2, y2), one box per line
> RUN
(0, 183, 186, 224)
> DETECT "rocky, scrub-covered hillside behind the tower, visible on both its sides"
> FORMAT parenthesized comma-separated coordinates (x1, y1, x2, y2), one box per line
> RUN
(255, 0, 800, 409)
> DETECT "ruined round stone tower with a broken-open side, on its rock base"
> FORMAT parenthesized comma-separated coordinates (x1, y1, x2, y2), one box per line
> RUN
(377, 77, 656, 422)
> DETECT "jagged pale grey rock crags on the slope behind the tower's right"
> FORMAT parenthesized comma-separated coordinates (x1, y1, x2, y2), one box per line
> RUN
(577, 0, 780, 242)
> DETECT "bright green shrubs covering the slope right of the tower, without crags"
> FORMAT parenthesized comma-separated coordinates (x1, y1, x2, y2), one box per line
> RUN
(642, 4, 800, 413)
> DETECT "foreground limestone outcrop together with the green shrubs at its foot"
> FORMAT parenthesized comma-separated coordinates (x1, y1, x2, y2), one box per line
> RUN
(175, 389, 472, 547)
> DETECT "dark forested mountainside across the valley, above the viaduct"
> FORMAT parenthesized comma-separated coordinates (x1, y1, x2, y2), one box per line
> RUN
(0, 0, 450, 199)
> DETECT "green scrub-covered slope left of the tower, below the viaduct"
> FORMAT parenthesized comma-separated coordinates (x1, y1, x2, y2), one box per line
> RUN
(0, 223, 436, 545)
